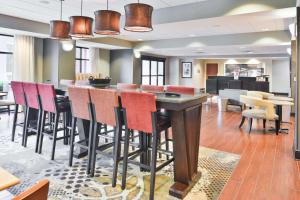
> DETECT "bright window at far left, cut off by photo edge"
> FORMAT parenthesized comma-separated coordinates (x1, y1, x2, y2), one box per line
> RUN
(0, 34, 14, 91)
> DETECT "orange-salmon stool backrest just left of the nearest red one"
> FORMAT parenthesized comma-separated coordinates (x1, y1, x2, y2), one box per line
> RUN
(90, 89, 119, 126)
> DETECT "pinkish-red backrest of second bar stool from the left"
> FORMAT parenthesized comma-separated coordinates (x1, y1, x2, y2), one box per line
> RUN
(23, 82, 40, 109)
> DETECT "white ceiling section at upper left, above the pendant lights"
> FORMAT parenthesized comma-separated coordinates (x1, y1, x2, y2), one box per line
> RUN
(0, 0, 206, 23)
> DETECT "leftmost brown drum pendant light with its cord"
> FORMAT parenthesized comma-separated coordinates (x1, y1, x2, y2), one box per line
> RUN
(50, 0, 70, 39)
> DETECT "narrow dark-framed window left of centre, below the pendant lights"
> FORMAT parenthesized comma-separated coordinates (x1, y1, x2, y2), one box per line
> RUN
(76, 47, 91, 73)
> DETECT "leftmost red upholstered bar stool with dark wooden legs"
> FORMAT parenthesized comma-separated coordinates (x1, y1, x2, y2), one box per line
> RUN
(11, 81, 26, 145)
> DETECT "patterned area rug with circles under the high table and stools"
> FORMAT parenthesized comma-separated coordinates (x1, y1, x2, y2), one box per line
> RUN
(0, 129, 240, 200)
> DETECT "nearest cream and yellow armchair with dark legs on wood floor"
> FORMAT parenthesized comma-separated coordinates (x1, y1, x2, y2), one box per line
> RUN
(240, 95, 280, 135)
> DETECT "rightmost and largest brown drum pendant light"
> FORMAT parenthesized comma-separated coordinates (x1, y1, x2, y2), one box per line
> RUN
(124, 1, 153, 32)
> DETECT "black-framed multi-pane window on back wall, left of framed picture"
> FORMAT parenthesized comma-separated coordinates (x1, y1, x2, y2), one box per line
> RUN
(142, 56, 165, 86)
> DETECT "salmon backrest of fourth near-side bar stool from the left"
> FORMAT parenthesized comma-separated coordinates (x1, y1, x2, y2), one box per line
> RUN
(68, 87, 91, 120)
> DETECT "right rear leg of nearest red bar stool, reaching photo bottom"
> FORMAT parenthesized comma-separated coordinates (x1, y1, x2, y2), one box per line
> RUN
(149, 132, 158, 200)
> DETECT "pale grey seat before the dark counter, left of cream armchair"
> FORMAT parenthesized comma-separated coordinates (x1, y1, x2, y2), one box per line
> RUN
(219, 89, 247, 111)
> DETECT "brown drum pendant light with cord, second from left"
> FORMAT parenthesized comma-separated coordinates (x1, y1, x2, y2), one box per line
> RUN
(70, 0, 93, 38)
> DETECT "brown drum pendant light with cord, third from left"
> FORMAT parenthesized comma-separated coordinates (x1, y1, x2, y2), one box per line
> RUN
(94, 0, 121, 35)
